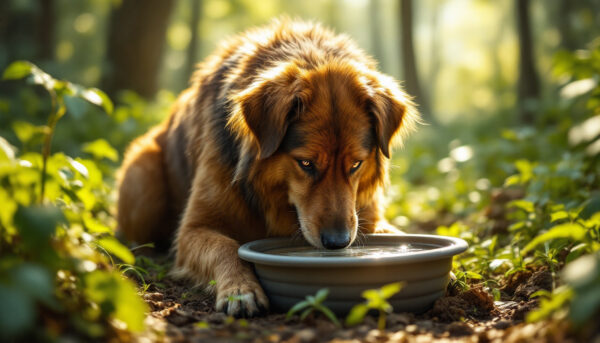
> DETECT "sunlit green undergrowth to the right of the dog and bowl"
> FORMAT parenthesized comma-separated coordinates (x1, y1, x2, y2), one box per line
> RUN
(388, 40, 600, 332)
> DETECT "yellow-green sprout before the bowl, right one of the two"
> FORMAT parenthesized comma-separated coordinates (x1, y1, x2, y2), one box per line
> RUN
(346, 282, 404, 330)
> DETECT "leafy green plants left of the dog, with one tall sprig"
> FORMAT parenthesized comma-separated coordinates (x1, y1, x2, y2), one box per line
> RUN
(0, 62, 147, 341)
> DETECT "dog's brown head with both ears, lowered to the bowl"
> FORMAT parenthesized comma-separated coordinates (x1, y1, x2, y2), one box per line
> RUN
(229, 63, 418, 249)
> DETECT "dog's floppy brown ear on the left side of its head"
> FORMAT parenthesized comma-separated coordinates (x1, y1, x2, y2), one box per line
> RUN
(229, 63, 306, 159)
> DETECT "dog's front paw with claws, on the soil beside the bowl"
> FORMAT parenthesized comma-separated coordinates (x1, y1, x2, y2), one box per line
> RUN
(216, 281, 269, 317)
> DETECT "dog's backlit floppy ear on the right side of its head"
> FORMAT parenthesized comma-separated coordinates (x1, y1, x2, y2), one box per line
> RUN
(365, 72, 420, 158)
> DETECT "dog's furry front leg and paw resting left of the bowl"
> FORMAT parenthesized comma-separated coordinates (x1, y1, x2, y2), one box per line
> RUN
(174, 226, 269, 317)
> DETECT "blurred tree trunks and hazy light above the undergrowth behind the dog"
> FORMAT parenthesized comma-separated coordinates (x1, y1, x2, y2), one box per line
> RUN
(0, 0, 600, 142)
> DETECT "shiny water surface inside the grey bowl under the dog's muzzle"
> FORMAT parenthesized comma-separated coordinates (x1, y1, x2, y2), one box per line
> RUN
(266, 244, 433, 258)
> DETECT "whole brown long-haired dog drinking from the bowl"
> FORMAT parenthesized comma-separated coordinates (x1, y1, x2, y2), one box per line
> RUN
(118, 20, 418, 316)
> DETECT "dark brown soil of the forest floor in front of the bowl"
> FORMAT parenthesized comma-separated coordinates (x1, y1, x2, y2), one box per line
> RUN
(131, 257, 576, 342)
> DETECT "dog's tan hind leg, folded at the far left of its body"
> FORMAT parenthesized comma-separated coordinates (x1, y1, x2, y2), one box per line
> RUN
(117, 126, 169, 244)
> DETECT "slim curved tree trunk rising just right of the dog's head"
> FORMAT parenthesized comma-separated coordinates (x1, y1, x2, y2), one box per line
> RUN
(400, 0, 433, 124)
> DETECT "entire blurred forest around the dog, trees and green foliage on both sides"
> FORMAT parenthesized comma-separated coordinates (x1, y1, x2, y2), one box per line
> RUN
(0, 0, 600, 340)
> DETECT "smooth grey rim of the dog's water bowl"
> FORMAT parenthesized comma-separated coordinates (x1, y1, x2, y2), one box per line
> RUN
(238, 234, 468, 268)
